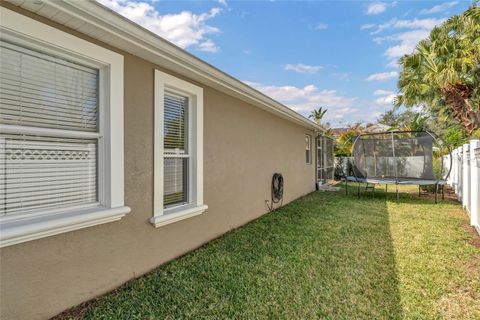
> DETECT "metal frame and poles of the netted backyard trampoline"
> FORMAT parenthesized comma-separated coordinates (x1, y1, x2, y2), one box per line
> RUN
(344, 130, 452, 203)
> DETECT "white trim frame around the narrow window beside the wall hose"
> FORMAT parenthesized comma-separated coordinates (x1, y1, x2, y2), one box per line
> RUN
(150, 70, 208, 228)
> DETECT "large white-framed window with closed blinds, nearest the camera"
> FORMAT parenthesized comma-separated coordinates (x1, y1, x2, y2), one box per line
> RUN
(0, 9, 130, 246)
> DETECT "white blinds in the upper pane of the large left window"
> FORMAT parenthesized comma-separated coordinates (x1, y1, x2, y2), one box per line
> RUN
(0, 41, 98, 132)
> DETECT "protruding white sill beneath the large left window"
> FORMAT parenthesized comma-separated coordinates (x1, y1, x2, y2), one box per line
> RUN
(0, 206, 130, 247)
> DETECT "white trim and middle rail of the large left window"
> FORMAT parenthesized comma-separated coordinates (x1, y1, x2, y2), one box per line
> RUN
(0, 7, 130, 247)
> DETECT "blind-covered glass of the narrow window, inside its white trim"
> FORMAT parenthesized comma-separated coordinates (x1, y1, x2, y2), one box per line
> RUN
(163, 91, 190, 207)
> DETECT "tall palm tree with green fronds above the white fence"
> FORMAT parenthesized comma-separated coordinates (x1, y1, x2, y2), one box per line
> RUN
(396, 4, 480, 135)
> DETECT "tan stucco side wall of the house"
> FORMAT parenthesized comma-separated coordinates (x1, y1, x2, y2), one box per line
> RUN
(0, 5, 315, 320)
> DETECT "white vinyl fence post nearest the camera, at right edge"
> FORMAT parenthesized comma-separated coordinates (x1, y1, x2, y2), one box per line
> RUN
(470, 140, 480, 233)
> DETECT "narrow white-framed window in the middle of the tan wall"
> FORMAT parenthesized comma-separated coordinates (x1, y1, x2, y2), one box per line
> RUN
(151, 71, 207, 227)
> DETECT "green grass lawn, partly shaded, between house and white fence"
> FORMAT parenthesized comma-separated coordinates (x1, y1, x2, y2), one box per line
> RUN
(60, 187, 480, 319)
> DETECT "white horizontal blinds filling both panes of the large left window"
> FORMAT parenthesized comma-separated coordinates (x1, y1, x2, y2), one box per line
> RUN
(0, 41, 100, 215)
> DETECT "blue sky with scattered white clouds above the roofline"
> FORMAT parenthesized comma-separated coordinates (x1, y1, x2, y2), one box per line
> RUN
(97, 0, 471, 127)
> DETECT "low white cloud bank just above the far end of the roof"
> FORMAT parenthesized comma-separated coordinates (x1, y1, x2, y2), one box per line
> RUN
(245, 81, 358, 121)
